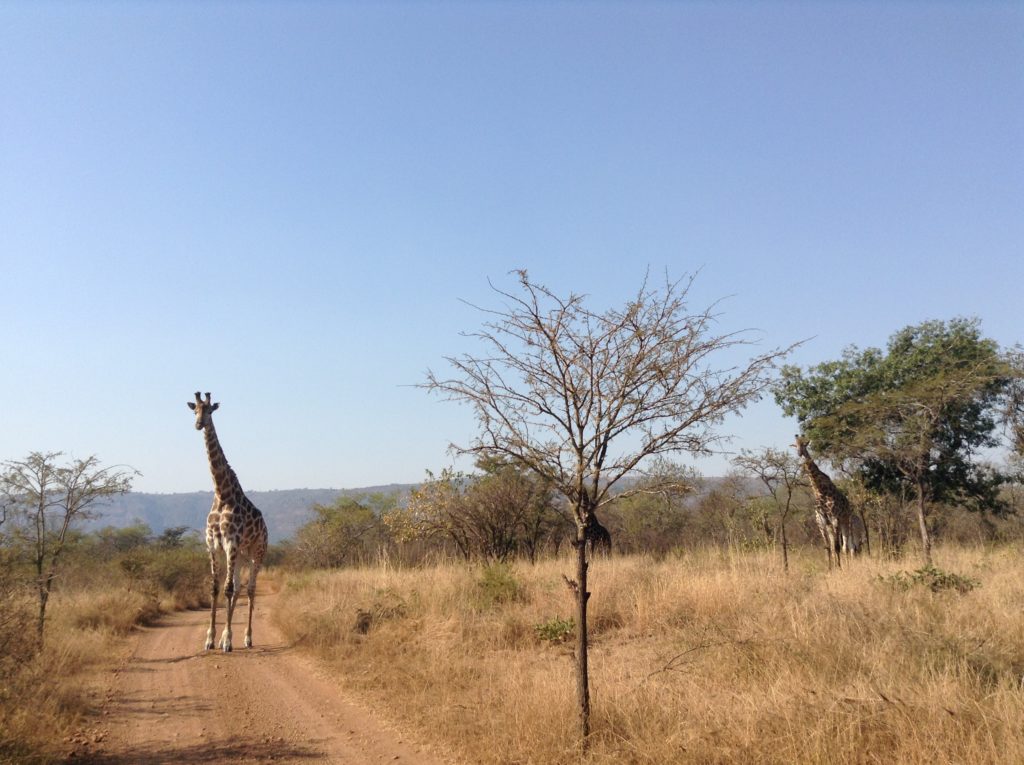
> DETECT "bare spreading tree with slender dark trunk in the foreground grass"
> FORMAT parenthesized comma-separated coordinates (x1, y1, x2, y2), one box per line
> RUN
(424, 270, 784, 748)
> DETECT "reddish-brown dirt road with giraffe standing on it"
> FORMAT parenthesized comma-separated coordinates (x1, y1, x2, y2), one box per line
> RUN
(69, 593, 450, 765)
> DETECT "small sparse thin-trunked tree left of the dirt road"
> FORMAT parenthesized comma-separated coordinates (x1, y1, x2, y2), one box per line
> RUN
(0, 452, 137, 646)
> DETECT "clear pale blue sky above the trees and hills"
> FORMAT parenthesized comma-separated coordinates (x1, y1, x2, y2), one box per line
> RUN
(0, 2, 1024, 492)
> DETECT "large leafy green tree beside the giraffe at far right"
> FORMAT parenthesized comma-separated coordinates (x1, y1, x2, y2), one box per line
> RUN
(775, 318, 1013, 562)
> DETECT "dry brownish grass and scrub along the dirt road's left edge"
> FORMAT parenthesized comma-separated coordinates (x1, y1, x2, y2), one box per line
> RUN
(0, 550, 208, 763)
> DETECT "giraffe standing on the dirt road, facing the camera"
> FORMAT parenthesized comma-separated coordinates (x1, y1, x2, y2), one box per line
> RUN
(188, 391, 267, 653)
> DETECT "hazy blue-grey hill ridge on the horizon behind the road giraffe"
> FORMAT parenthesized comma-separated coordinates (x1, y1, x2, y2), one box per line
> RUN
(85, 483, 414, 542)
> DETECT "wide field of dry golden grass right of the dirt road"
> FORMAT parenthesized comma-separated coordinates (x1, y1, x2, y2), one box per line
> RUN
(278, 549, 1024, 763)
